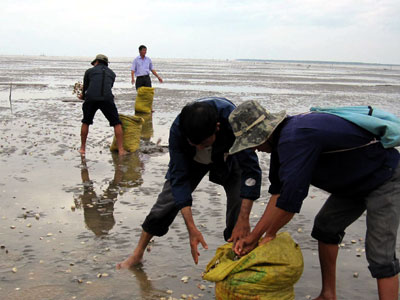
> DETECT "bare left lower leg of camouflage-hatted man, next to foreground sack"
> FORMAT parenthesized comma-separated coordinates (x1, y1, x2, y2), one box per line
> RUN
(314, 242, 339, 300)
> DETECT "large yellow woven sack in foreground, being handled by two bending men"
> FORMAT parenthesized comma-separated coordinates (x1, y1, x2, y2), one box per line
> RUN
(203, 232, 303, 300)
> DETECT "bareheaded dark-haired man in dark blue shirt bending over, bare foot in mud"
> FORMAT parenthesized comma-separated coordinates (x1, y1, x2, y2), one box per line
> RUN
(117, 98, 261, 269)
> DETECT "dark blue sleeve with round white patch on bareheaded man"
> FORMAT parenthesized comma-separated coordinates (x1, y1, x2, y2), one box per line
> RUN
(236, 149, 261, 201)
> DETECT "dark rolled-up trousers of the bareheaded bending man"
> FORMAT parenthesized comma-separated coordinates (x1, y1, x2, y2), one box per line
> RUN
(142, 162, 242, 240)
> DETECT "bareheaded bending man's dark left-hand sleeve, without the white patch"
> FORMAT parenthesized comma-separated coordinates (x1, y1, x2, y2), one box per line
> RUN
(168, 123, 193, 209)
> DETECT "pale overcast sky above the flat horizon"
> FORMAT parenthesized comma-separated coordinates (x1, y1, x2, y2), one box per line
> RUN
(0, 0, 400, 64)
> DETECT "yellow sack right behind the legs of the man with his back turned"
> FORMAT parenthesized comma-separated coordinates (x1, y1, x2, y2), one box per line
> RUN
(110, 114, 144, 152)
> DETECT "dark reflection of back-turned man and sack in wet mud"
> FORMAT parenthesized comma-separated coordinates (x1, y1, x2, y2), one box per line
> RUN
(75, 153, 143, 236)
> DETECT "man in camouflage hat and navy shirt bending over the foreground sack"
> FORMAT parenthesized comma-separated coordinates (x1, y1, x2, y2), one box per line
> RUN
(229, 101, 400, 300)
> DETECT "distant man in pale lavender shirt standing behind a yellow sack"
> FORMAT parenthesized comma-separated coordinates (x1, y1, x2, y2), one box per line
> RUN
(131, 45, 163, 89)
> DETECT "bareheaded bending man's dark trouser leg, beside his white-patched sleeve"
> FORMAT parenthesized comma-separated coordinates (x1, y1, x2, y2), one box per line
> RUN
(223, 161, 242, 241)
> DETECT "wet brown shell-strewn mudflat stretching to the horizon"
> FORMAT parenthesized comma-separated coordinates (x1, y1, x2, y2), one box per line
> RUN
(0, 57, 400, 299)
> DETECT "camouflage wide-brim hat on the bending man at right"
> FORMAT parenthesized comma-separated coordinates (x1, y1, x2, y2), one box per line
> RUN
(229, 100, 287, 154)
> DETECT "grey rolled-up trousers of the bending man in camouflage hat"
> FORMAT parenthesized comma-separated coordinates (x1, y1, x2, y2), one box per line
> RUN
(311, 165, 400, 278)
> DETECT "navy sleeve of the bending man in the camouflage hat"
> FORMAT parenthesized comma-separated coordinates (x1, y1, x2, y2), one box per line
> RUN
(269, 131, 321, 213)
